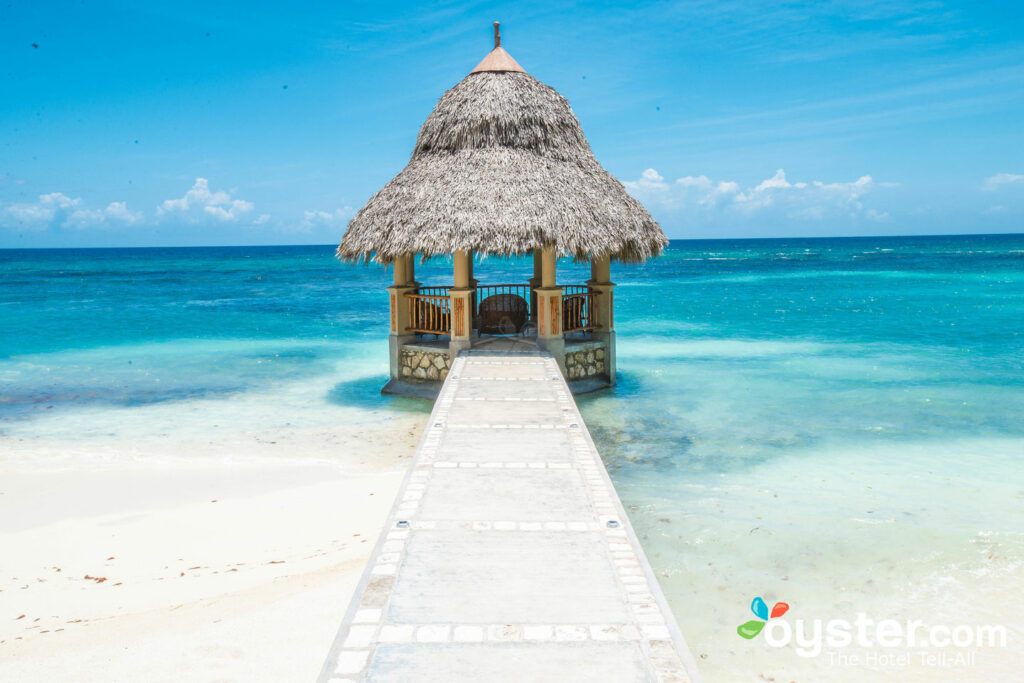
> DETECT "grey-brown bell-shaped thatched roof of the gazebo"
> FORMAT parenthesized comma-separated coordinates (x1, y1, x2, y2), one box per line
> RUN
(338, 29, 668, 263)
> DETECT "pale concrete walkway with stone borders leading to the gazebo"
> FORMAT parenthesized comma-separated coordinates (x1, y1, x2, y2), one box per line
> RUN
(321, 350, 697, 682)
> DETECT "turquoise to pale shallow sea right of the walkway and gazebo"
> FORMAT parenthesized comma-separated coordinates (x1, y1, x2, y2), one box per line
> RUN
(582, 237, 1024, 681)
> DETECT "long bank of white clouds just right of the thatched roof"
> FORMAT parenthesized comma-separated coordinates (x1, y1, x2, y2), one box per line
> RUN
(623, 169, 896, 221)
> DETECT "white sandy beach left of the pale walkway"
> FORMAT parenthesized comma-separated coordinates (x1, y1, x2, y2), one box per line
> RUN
(0, 416, 422, 681)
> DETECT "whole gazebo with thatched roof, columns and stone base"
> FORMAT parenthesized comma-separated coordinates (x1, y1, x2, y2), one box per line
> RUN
(338, 23, 668, 393)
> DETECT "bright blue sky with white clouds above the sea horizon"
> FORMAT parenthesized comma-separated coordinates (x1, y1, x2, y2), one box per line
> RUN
(0, 0, 1024, 247)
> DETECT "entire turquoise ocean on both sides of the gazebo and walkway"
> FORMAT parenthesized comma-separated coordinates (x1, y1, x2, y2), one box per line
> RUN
(0, 236, 1024, 681)
